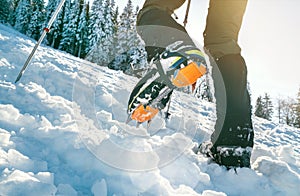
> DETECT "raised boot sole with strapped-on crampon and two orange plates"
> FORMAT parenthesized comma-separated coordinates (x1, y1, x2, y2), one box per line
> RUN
(127, 43, 207, 127)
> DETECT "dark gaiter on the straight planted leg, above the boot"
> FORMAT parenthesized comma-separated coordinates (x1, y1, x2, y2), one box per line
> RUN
(211, 54, 254, 147)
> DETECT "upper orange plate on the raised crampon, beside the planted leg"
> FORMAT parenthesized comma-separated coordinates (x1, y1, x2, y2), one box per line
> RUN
(172, 62, 206, 88)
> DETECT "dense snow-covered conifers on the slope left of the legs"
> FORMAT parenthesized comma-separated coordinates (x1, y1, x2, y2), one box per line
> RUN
(0, 0, 147, 72)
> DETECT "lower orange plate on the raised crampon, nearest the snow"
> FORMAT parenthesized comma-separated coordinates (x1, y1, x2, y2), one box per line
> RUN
(131, 105, 159, 123)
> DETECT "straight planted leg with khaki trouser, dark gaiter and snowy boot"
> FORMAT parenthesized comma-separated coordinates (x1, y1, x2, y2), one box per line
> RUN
(204, 0, 254, 167)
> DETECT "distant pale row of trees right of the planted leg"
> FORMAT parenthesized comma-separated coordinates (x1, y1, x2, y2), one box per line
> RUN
(254, 88, 300, 128)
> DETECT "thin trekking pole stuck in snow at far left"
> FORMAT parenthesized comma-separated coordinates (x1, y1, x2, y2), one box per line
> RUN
(15, 0, 65, 83)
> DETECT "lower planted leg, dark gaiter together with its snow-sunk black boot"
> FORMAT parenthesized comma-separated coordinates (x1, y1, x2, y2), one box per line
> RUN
(199, 54, 254, 168)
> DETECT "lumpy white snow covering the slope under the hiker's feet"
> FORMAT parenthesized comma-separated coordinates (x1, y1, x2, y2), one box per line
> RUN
(0, 25, 300, 196)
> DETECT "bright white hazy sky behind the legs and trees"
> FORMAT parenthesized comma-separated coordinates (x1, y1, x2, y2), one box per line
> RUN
(116, 0, 300, 99)
